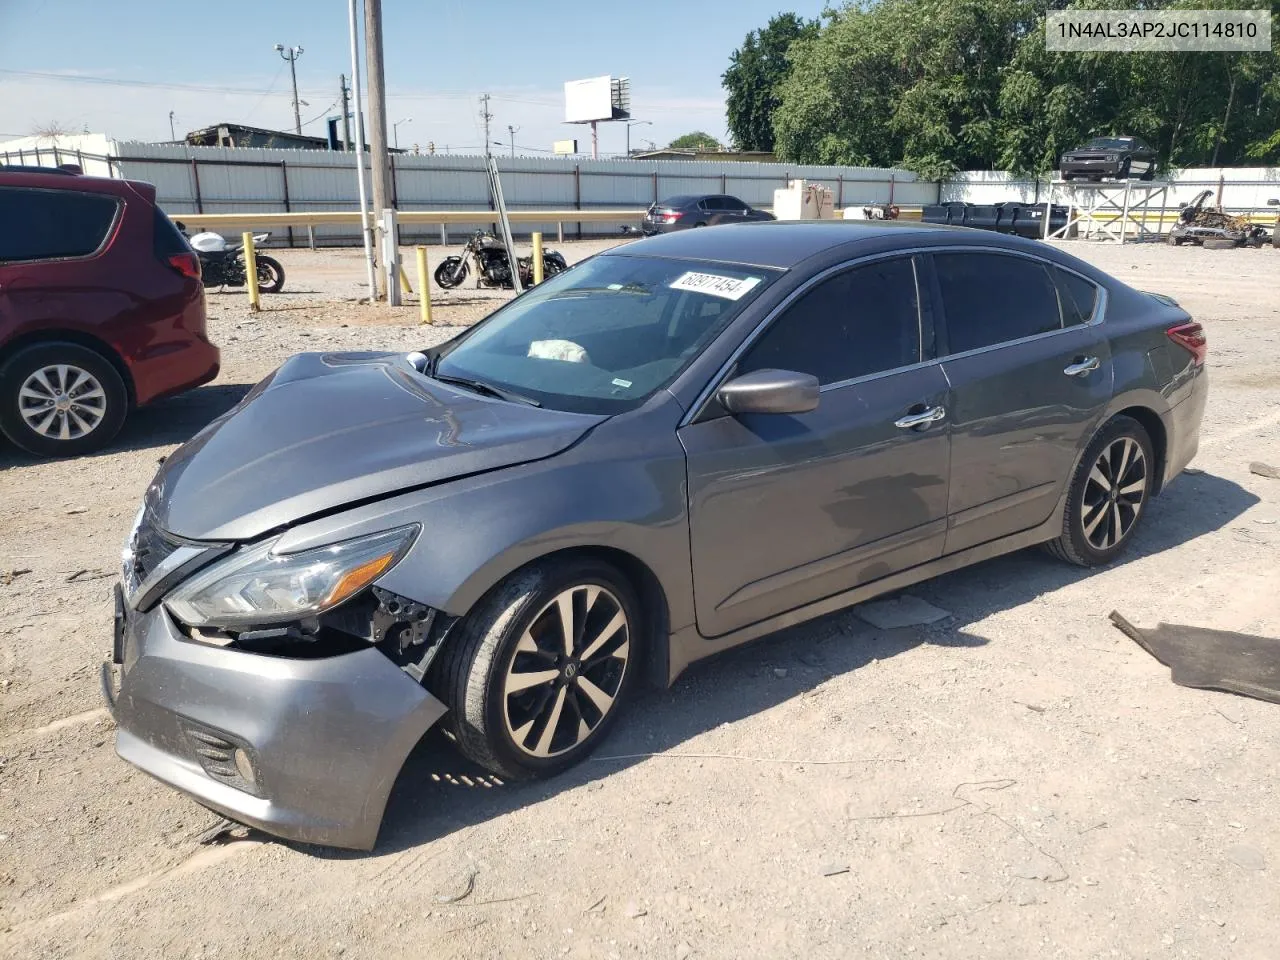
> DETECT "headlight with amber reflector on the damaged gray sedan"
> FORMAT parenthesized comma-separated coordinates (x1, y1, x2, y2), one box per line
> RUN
(165, 524, 419, 628)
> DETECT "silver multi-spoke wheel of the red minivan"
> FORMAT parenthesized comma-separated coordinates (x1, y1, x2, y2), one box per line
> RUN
(0, 343, 128, 457)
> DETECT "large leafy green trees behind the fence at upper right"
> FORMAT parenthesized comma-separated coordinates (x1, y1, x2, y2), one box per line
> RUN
(773, 0, 1280, 178)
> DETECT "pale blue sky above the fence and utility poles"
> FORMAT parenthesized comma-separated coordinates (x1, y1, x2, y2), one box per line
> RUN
(0, 0, 827, 152)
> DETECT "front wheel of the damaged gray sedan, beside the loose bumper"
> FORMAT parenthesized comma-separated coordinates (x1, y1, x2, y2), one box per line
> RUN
(430, 558, 643, 780)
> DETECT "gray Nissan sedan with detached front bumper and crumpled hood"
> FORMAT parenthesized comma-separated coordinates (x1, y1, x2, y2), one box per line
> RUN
(104, 221, 1207, 847)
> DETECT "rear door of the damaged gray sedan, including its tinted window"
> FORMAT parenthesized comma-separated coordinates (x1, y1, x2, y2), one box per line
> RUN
(931, 250, 1114, 553)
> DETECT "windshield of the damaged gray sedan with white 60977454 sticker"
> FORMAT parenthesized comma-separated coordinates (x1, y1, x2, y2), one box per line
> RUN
(431, 255, 777, 415)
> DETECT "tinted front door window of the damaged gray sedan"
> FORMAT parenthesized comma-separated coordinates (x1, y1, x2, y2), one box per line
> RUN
(739, 257, 920, 384)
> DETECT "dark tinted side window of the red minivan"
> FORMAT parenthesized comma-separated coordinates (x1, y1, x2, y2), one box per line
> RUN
(0, 187, 120, 261)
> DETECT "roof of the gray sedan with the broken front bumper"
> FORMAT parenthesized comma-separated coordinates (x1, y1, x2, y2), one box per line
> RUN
(602, 220, 1047, 270)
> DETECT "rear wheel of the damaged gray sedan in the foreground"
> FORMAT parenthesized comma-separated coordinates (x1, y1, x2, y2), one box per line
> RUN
(1046, 416, 1156, 567)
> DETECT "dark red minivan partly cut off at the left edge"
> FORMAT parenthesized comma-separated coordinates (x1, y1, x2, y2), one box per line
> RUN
(0, 166, 219, 457)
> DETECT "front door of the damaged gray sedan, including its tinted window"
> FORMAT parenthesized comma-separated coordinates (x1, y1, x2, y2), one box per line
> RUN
(680, 257, 948, 636)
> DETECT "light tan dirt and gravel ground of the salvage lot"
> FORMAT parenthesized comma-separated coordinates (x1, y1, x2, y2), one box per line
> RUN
(0, 235, 1280, 960)
